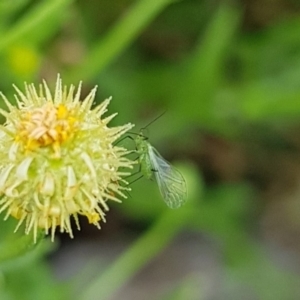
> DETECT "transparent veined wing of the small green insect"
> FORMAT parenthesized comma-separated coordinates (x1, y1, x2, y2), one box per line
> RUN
(149, 144, 187, 208)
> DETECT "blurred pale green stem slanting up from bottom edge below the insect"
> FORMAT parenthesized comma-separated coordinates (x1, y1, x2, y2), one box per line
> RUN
(79, 208, 190, 300)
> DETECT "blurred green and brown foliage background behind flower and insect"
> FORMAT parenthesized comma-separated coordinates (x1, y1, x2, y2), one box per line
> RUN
(0, 0, 300, 300)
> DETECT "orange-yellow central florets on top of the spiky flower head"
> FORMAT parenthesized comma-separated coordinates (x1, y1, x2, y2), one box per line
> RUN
(16, 103, 78, 157)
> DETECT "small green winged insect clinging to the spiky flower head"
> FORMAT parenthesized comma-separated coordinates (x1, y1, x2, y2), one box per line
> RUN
(135, 132, 187, 208)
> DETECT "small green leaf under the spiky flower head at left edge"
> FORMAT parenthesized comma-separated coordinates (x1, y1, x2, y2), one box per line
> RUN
(0, 231, 45, 264)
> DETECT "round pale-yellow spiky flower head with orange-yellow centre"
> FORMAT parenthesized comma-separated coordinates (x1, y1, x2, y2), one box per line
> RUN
(0, 76, 133, 240)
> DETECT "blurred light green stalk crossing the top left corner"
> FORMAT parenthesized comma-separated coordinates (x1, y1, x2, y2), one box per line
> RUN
(0, 0, 73, 53)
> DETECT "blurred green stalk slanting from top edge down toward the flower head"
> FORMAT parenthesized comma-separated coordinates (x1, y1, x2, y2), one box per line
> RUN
(68, 0, 174, 82)
